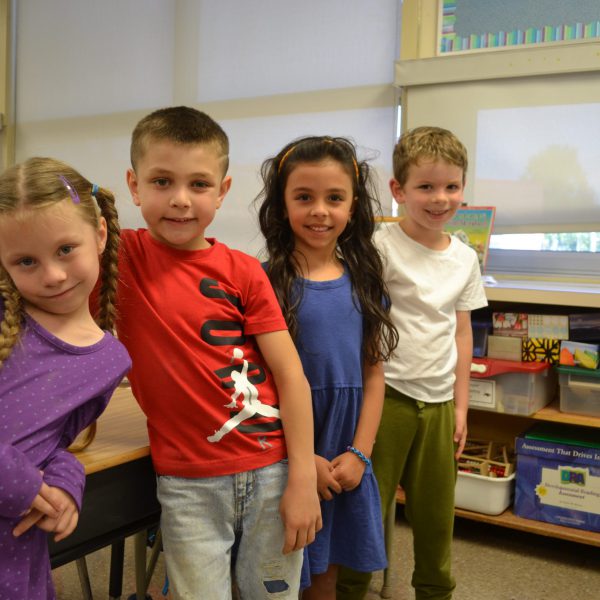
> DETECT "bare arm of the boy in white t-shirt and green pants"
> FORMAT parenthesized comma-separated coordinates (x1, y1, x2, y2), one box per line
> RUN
(454, 310, 473, 459)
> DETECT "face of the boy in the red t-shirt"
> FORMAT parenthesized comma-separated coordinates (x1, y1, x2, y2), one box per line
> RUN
(127, 141, 231, 250)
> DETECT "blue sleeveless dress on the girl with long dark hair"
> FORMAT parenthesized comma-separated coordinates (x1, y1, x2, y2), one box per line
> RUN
(296, 273, 387, 589)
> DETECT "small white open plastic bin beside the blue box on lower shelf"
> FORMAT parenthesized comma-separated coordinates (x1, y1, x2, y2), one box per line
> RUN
(454, 471, 515, 515)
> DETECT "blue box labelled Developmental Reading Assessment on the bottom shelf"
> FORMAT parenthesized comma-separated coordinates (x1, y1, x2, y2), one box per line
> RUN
(514, 423, 600, 531)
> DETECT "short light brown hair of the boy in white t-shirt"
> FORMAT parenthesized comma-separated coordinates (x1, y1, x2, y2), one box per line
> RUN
(393, 127, 469, 185)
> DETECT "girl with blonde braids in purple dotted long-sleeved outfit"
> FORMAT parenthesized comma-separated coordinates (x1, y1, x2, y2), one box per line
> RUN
(0, 158, 130, 600)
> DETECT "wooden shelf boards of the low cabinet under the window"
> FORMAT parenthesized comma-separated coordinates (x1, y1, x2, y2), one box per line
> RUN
(398, 280, 600, 547)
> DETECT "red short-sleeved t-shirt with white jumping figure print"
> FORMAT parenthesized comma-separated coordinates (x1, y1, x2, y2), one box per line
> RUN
(117, 229, 287, 477)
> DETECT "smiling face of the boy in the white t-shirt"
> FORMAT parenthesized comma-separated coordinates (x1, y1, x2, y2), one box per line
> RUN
(390, 160, 464, 239)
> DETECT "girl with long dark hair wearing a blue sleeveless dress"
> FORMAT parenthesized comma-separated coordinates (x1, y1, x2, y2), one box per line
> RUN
(256, 136, 397, 600)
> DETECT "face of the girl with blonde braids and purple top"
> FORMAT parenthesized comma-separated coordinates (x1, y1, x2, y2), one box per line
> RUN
(0, 198, 106, 316)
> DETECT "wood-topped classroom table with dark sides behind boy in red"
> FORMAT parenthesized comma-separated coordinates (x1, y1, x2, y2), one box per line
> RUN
(49, 386, 160, 598)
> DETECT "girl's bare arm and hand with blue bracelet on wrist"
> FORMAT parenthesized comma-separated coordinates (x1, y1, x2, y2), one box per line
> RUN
(332, 362, 385, 491)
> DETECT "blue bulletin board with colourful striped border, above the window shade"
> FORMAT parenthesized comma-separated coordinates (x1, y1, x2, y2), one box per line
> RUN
(438, 0, 600, 55)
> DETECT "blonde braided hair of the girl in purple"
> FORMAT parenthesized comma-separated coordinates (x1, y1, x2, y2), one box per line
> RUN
(0, 157, 120, 367)
